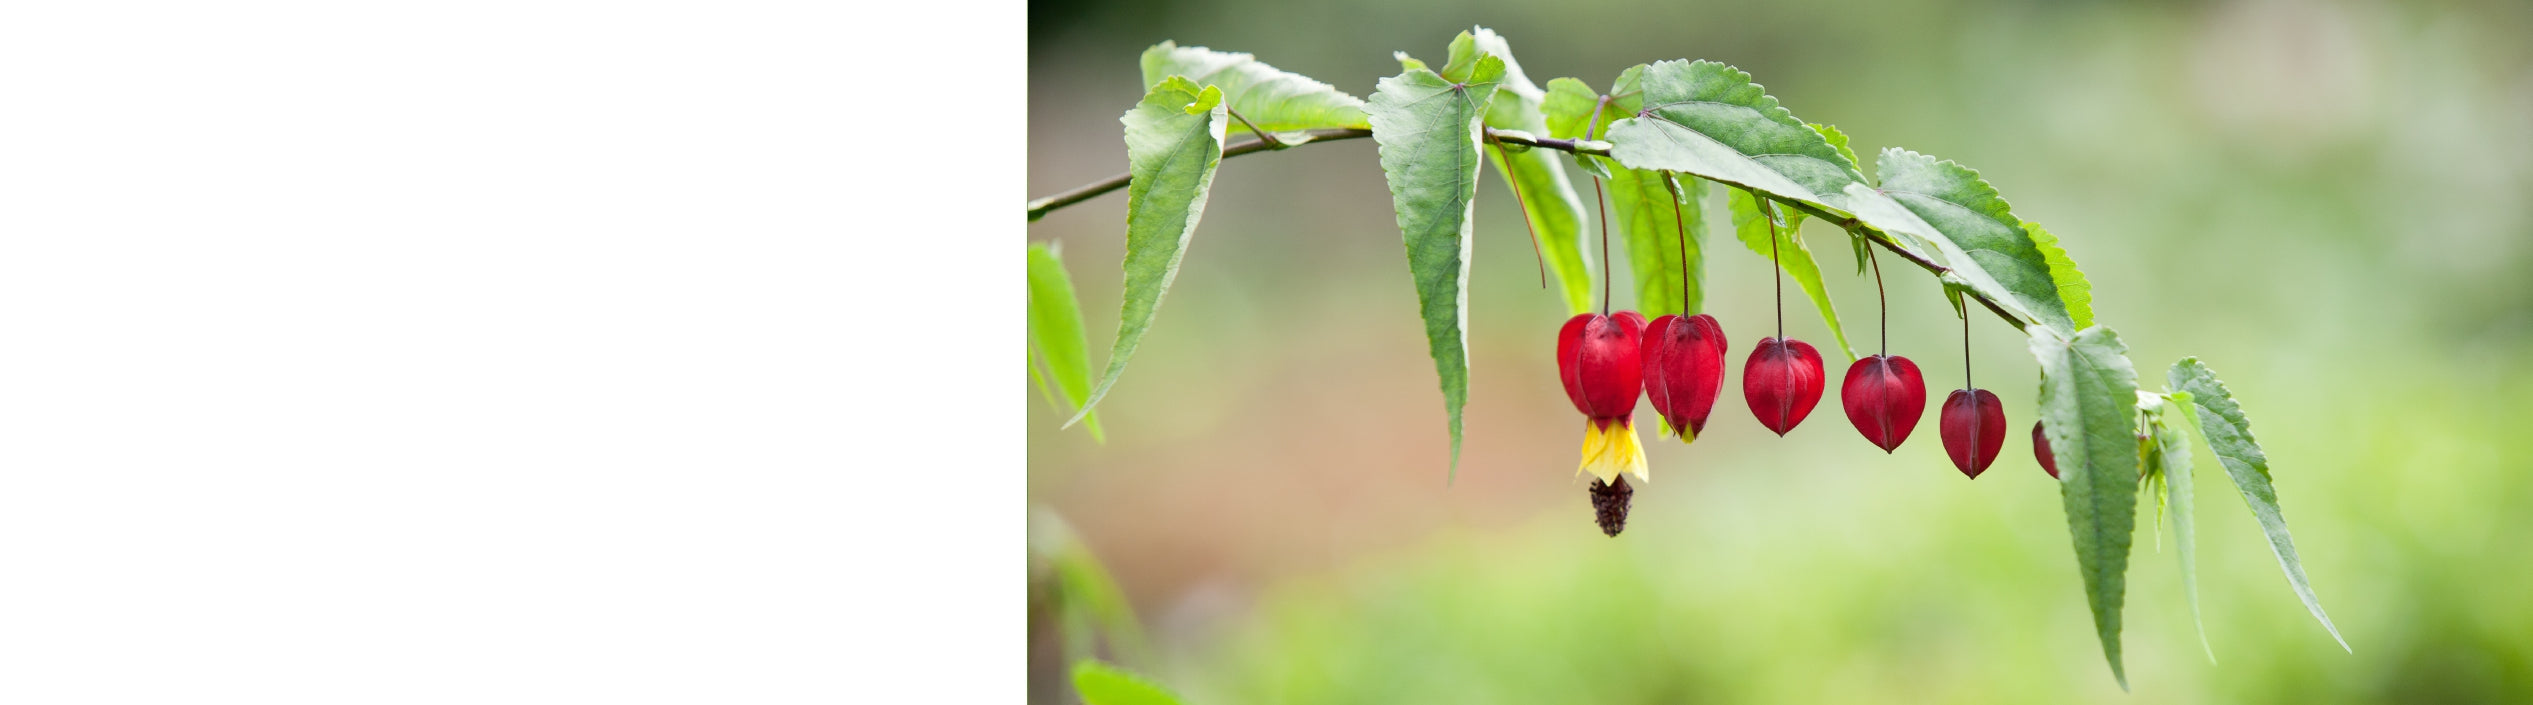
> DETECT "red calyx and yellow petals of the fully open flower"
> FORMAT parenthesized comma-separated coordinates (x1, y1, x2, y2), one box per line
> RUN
(1558, 312, 1646, 482)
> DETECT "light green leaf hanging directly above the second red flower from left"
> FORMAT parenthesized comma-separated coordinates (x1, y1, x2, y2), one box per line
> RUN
(1608, 170, 1707, 320)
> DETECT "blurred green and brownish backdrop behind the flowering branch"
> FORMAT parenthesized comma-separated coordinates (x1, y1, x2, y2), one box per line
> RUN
(1011, 0, 2533, 705)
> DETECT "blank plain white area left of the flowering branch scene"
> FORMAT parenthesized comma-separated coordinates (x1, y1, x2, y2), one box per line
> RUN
(0, 3, 1026, 702)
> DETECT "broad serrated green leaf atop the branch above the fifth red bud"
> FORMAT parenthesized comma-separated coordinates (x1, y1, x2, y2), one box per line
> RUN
(1874, 150, 2080, 332)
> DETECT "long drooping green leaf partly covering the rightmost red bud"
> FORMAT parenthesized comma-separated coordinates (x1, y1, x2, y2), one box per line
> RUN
(2026, 327, 2140, 690)
